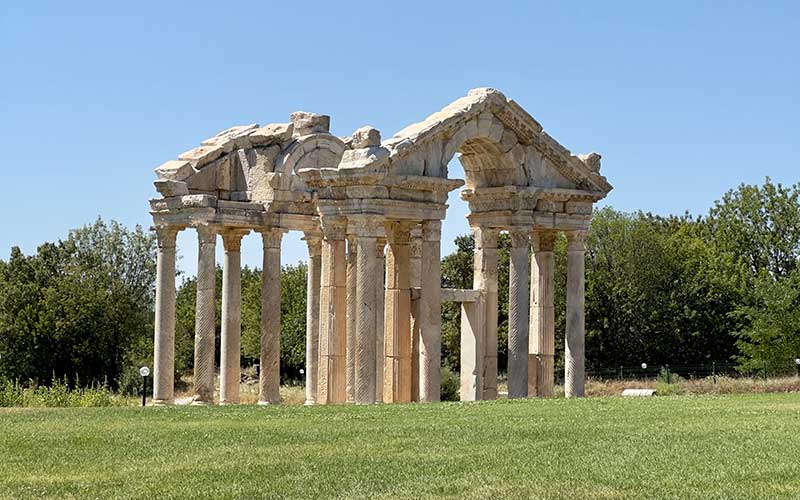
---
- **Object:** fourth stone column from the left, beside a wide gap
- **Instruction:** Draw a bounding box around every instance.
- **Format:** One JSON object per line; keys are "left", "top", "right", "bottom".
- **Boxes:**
{"left": 258, "top": 228, "right": 284, "bottom": 405}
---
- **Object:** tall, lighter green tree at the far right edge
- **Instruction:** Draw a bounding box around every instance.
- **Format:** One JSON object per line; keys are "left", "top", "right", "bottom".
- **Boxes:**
{"left": 707, "top": 178, "right": 800, "bottom": 371}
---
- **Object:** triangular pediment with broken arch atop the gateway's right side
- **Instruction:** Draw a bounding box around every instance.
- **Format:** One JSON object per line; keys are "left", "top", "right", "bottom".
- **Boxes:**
{"left": 382, "top": 88, "right": 612, "bottom": 195}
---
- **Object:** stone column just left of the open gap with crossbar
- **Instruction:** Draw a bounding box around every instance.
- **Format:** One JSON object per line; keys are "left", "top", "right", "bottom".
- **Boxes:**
{"left": 419, "top": 220, "right": 442, "bottom": 401}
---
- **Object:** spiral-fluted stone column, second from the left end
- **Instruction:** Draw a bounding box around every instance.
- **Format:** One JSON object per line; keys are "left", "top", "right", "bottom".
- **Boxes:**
{"left": 192, "top": 225, "right": 217, "bottom": 405}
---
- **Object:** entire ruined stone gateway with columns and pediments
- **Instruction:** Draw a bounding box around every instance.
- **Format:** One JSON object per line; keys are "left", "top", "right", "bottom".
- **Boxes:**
{"left": 150, "top": 88, "right": 612, "bottom": 404}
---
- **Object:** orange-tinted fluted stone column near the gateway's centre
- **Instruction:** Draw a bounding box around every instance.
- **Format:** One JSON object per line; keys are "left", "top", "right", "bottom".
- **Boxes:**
{"left": 383, "top": 222, "right": 411, "bottom": 403}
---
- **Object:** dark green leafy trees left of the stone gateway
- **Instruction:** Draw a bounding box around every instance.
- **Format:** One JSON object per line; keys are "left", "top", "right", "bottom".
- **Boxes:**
{"left": 0, "top": 219, "right": 155, "bottom": 386}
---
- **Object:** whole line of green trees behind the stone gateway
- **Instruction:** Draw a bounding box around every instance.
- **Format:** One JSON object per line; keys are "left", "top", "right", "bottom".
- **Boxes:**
{"left": 0, "top": 179, "right": 800, "bottom": 391}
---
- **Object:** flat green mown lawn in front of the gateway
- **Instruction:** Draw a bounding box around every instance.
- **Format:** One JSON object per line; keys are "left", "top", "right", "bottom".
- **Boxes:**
{"left": 0, "top": 394, "right": 800, "bottom": 500}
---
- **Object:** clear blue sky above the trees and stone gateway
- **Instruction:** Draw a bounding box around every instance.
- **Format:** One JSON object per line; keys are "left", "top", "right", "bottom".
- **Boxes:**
{"left": 0, "top": 0, "right": 800, "bottom": 274}
